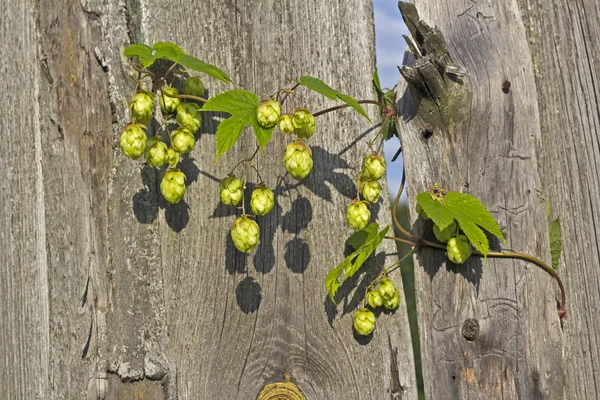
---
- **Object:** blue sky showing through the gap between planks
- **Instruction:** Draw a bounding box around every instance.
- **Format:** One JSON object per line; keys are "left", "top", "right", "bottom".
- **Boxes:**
{"left": 373, "top": 0, "right": 408, "bottom": 196}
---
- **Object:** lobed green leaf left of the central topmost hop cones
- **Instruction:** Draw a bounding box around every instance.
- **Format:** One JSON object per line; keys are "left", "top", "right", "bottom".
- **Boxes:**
{"left": 200, "top": 90, "right": 274, "bottom": 161}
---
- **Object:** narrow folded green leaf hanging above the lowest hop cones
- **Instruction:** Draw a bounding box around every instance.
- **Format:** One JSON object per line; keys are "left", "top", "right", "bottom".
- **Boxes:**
{"left": 325, "top": 222, "right": 390, "bottom": 304}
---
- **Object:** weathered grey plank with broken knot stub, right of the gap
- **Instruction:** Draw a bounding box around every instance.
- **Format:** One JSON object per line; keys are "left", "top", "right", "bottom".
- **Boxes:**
{"left": 399, "top": 0, "right": 565, "bottom": 399}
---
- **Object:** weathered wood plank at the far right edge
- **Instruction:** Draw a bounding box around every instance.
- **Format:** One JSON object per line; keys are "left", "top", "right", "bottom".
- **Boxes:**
{"left": 520, "top": 1, "right": 600, "bottom": 399}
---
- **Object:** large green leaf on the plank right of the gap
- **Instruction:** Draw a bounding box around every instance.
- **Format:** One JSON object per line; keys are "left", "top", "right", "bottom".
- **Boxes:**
{"left": 417, "top": 192, "right": 506, "bottom": 256}
